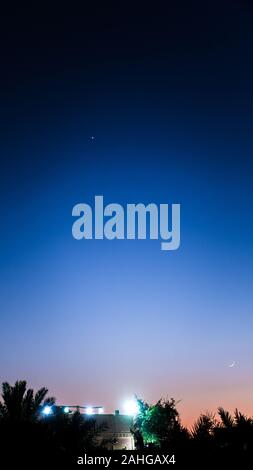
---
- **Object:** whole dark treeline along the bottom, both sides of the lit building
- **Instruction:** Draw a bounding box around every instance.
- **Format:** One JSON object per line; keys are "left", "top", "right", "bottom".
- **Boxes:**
{"left": 0, "top": 381, "right": 253, "bottom": 469}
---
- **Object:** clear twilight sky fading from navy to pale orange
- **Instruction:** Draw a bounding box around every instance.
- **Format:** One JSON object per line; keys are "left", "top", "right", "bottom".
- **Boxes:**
{"left": 0, "top": 0, "right": 253, "bottom": 424}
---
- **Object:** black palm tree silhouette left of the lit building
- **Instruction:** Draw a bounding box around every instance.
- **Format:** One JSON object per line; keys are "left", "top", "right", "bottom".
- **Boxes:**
{"left": 0, "top": 380, "right": 100, "bottom": 468}
